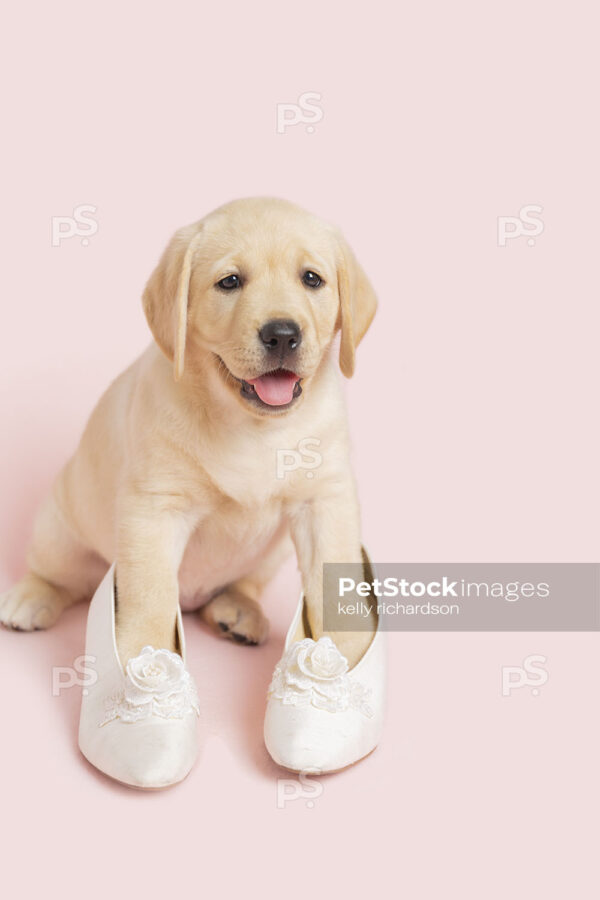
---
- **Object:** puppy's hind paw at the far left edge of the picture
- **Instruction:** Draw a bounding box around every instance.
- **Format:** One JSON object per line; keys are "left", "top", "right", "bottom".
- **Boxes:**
{"left": 0, "top": 573, "right": 65, "bottom": 631}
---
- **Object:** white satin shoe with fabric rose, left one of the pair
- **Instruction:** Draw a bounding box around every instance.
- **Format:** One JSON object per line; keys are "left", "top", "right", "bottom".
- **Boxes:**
{"left": 79, "top": 565, "right": 198, "bottom": 789}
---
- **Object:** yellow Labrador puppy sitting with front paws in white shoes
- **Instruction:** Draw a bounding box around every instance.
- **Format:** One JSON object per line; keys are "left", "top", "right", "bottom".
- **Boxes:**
{"left": 0, "top": 198, "right": 376, "bottom": 665}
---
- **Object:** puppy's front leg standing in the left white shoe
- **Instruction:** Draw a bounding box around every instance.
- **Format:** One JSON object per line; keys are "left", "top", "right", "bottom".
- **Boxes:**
{"left": 116, "top": 492, "right": 198, "bottom": 665}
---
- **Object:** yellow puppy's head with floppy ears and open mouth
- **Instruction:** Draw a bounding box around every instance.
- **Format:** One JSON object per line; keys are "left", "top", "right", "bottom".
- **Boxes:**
{"left": 143, "top": 198, "right": 376, "bottom": 415}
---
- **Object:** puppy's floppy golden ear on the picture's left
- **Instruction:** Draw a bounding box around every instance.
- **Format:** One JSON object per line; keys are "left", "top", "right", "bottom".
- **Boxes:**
{"left": 142, "top": 223, "right": 202, "bottom": 381}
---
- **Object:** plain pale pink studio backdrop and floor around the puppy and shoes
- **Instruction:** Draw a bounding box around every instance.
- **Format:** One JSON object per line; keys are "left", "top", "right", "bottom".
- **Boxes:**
{"left": 0, "top": 0, "right": 600, "bottom": 900}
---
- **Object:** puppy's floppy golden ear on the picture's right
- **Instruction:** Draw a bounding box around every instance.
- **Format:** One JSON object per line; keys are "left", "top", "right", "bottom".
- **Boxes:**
{"left": 337, "top": 235, "right": 377, "bottom": 378}
